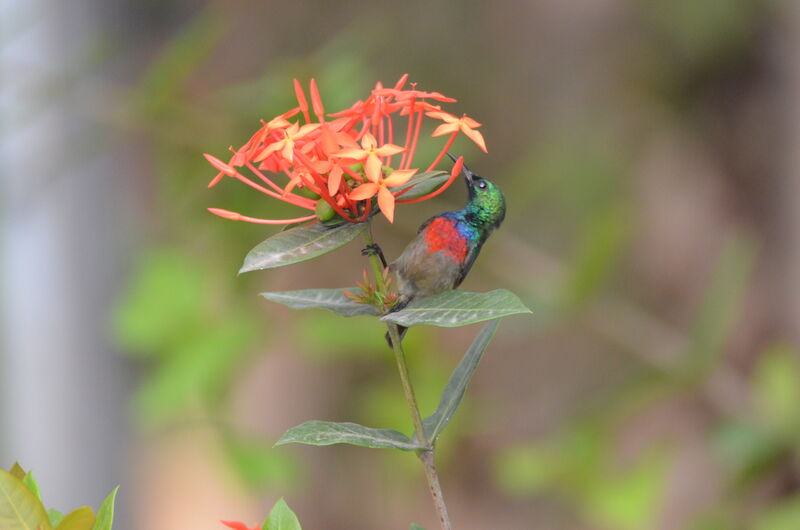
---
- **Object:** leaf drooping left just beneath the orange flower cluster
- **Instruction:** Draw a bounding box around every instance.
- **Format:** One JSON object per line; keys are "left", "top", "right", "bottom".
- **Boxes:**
{"left": 239, "top": 223, "right": 368, "bottom": 274}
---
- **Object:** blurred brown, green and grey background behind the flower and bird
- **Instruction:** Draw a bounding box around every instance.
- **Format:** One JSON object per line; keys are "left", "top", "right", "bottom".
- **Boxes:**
{"left": 0, "top": 0, "right": 800, "bottom": 530}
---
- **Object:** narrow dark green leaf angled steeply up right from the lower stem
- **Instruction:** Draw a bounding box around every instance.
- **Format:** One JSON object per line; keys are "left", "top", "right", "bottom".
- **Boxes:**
{"left": 422, "top": 319, "right": 500, "bottom": 444}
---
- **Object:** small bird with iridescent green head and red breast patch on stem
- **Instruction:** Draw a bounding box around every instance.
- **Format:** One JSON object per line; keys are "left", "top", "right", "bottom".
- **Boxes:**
{"left": 365, "top": 153, "right": 506, "bottom": 346}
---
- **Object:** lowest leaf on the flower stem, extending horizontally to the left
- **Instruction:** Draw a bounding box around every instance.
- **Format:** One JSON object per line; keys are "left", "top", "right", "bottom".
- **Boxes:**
{"left": 275, "top": 420, "right": 424, "bottom": 451}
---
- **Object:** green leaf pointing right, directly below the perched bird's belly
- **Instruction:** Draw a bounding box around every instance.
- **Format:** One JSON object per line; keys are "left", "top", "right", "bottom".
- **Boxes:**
{"left": 381, "top": 289, "right": 531, "bottom": 328}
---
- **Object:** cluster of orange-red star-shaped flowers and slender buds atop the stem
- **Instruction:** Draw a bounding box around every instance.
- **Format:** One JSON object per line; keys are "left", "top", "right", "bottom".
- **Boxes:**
{"left": 205, "top": 74, "right": 486, "bottom": 224}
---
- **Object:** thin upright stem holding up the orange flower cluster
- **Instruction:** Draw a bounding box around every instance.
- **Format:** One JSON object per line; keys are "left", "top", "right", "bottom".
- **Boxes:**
{"left": 364, "top": 226, "right": 452, "bottom": 530}
